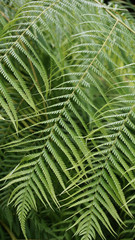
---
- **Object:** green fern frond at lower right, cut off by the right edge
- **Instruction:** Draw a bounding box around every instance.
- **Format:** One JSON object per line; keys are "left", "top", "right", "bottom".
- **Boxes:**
{"left": 67, "top": 80, "right": 135, "bottom": 239}
